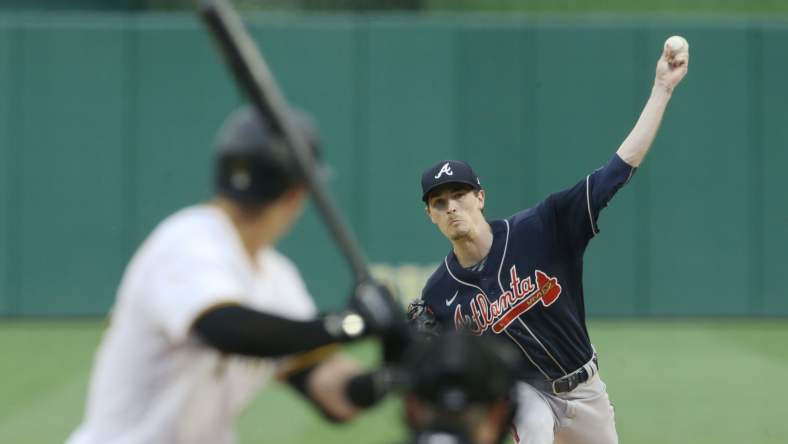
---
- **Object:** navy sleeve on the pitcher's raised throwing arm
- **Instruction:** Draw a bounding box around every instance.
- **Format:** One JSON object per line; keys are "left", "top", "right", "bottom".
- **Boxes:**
{"left": 543, "top": 154, "right": 636, "bottom": 251}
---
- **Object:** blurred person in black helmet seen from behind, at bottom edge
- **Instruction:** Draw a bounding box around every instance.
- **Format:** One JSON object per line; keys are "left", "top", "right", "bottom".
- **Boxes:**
{"left": 405, "top": 333, "right": 519, "bottom": 444}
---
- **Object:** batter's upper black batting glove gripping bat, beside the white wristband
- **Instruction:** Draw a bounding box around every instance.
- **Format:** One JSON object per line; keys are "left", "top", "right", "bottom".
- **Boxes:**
{"left": 348, "top": 281, "right": 411, "bottom": 362}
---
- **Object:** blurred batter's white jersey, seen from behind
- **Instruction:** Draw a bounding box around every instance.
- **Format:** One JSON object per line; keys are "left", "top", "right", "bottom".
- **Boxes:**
{"left": 68, "top": 206, "right": 316, "bottom": 444}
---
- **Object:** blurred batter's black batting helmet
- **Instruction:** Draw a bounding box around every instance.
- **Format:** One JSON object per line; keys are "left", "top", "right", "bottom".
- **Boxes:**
{"left": 215, "top": 106, "right": 318, "bottom": 206}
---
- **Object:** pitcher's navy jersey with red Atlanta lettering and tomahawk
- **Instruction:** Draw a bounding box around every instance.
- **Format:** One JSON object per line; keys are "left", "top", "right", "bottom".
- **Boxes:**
{"left": 421, "top": 155, "right": 635, "bottom": 380}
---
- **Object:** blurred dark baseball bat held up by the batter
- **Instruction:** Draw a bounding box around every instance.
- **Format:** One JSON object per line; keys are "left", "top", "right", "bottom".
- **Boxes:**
{"left": 195, "top": 0, "right": 372, "bottom": 284}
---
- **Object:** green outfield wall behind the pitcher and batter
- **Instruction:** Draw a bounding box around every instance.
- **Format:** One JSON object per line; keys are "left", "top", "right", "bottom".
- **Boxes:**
{"left": 0, "top": 14, "right": 788, "bottom": 316}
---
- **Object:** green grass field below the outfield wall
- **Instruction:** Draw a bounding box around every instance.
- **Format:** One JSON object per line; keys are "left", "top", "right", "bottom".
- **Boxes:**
{"left": 0, "top": 320, "right": 788, "bottom": 444}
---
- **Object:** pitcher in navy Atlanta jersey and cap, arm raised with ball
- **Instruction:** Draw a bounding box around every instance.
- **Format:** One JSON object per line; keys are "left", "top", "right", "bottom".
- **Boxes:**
{"left": 409, "top": 38, "right": 689, "bottom": 444}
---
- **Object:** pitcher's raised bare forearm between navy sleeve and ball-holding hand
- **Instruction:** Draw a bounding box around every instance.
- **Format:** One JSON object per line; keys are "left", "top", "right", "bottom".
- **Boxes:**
{"left": 616, "top": 83, "right": 672, "bottom": 167}
